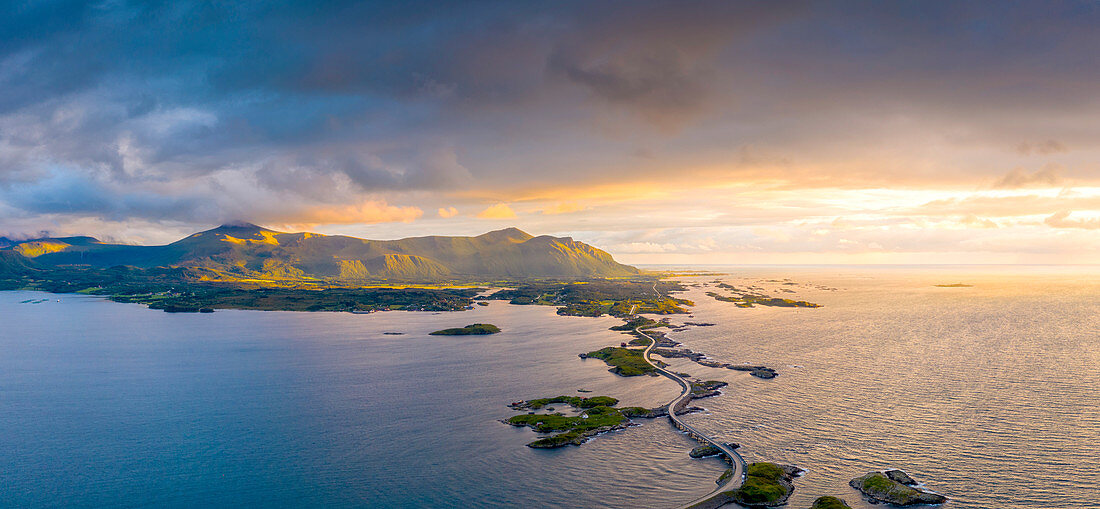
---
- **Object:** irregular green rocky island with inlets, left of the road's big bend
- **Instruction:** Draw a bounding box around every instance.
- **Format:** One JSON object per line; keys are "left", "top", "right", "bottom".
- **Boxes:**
{"left": 502, "top": 396, "right": 668, "bottom": 449}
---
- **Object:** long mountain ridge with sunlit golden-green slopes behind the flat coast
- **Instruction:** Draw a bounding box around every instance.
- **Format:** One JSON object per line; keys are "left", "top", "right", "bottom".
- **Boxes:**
{"left": 3, "top": 224, "right": 638, "bottom": 280}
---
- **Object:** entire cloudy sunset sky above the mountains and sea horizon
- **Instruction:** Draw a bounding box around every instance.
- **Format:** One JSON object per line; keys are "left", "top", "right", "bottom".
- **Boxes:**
{"left": 0, "top": 0, "right": 1100, "bottom": 264}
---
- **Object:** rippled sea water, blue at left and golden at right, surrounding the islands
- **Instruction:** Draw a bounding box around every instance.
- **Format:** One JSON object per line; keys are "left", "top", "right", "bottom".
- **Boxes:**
{"left": 0, "top": 267, "right": 1100, "bottom": 508}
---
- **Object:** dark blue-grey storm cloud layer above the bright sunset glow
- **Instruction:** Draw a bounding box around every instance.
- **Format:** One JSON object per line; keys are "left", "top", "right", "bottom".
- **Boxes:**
{"left": 0, "top": 1, "right": 1100, "bottom": 227}
